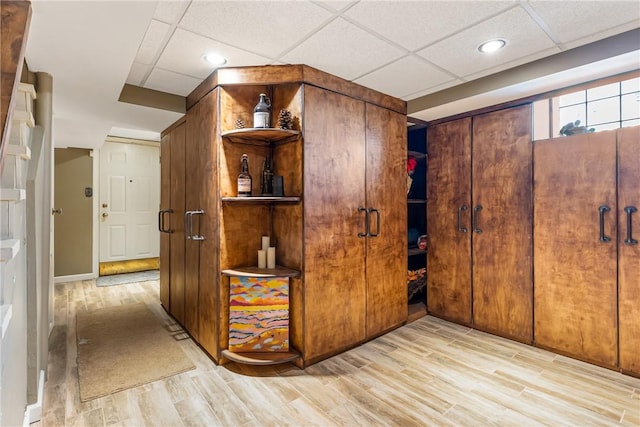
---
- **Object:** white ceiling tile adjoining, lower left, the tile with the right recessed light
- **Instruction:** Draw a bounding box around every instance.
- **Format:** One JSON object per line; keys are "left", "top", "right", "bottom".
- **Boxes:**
{"left": 355, "top": 55, "right": 454, "bottom": 98}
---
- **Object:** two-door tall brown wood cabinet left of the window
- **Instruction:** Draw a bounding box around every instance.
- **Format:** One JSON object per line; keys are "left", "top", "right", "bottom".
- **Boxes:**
{"left": 427, "top": 105, "right": 533, "bottom": 342}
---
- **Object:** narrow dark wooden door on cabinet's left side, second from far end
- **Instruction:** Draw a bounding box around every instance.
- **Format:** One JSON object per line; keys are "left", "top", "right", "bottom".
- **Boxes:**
{"left": 169, "top": 124, "right": 185, "bottom": 325}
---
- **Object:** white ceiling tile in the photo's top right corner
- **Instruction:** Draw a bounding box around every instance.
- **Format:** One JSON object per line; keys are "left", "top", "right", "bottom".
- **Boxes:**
{"left": 530, "top": 0, "right": 640, "bottom": 43}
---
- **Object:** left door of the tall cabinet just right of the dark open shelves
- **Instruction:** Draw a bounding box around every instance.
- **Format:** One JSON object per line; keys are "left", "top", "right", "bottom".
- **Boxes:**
{"left": 427, "top": 118, "right": 471, "bottom": 324}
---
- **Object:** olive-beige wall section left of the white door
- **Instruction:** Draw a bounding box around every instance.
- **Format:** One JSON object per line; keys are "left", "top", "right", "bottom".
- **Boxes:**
{"left": 54, "top": 148, "right": 95, "bottom": 277}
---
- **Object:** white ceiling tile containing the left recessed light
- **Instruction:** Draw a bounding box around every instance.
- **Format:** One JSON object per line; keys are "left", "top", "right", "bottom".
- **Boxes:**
{"left": 157, "top": 28, "right": 269, "bottom": 79}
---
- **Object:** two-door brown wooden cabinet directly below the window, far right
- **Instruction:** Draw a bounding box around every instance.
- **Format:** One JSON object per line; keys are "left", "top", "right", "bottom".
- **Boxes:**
{"left": 534, "top": 128, "right": 640, "bottom": 373}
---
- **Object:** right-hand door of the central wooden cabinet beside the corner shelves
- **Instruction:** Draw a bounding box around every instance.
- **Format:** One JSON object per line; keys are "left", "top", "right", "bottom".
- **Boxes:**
{"left": 366, "top": 104, "right": 407, "bottom": 338}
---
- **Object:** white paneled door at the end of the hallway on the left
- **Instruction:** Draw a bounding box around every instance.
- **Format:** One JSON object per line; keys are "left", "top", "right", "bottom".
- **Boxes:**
{"left": 99, "top": 142, "right": 160, "bottom": 262}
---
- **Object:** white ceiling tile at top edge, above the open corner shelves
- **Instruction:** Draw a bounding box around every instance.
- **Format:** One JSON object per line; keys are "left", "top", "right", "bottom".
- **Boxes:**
{"left": 180, "top": 1, "right": 331, "bottom": 58}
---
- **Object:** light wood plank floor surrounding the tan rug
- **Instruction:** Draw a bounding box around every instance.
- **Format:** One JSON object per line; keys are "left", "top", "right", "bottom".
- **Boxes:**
{"left": 38, "top": 281, "right": 640, "bottom": 426}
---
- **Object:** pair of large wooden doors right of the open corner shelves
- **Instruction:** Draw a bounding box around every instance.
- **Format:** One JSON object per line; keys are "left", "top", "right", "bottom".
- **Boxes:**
{"left": 304, "top": 86, "right": 407, "bottom": 360}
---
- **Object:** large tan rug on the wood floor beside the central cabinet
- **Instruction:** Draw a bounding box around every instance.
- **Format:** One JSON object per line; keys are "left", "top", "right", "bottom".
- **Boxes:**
{"left": 76, "top": 303, "right": 195, "bottom": 402}
